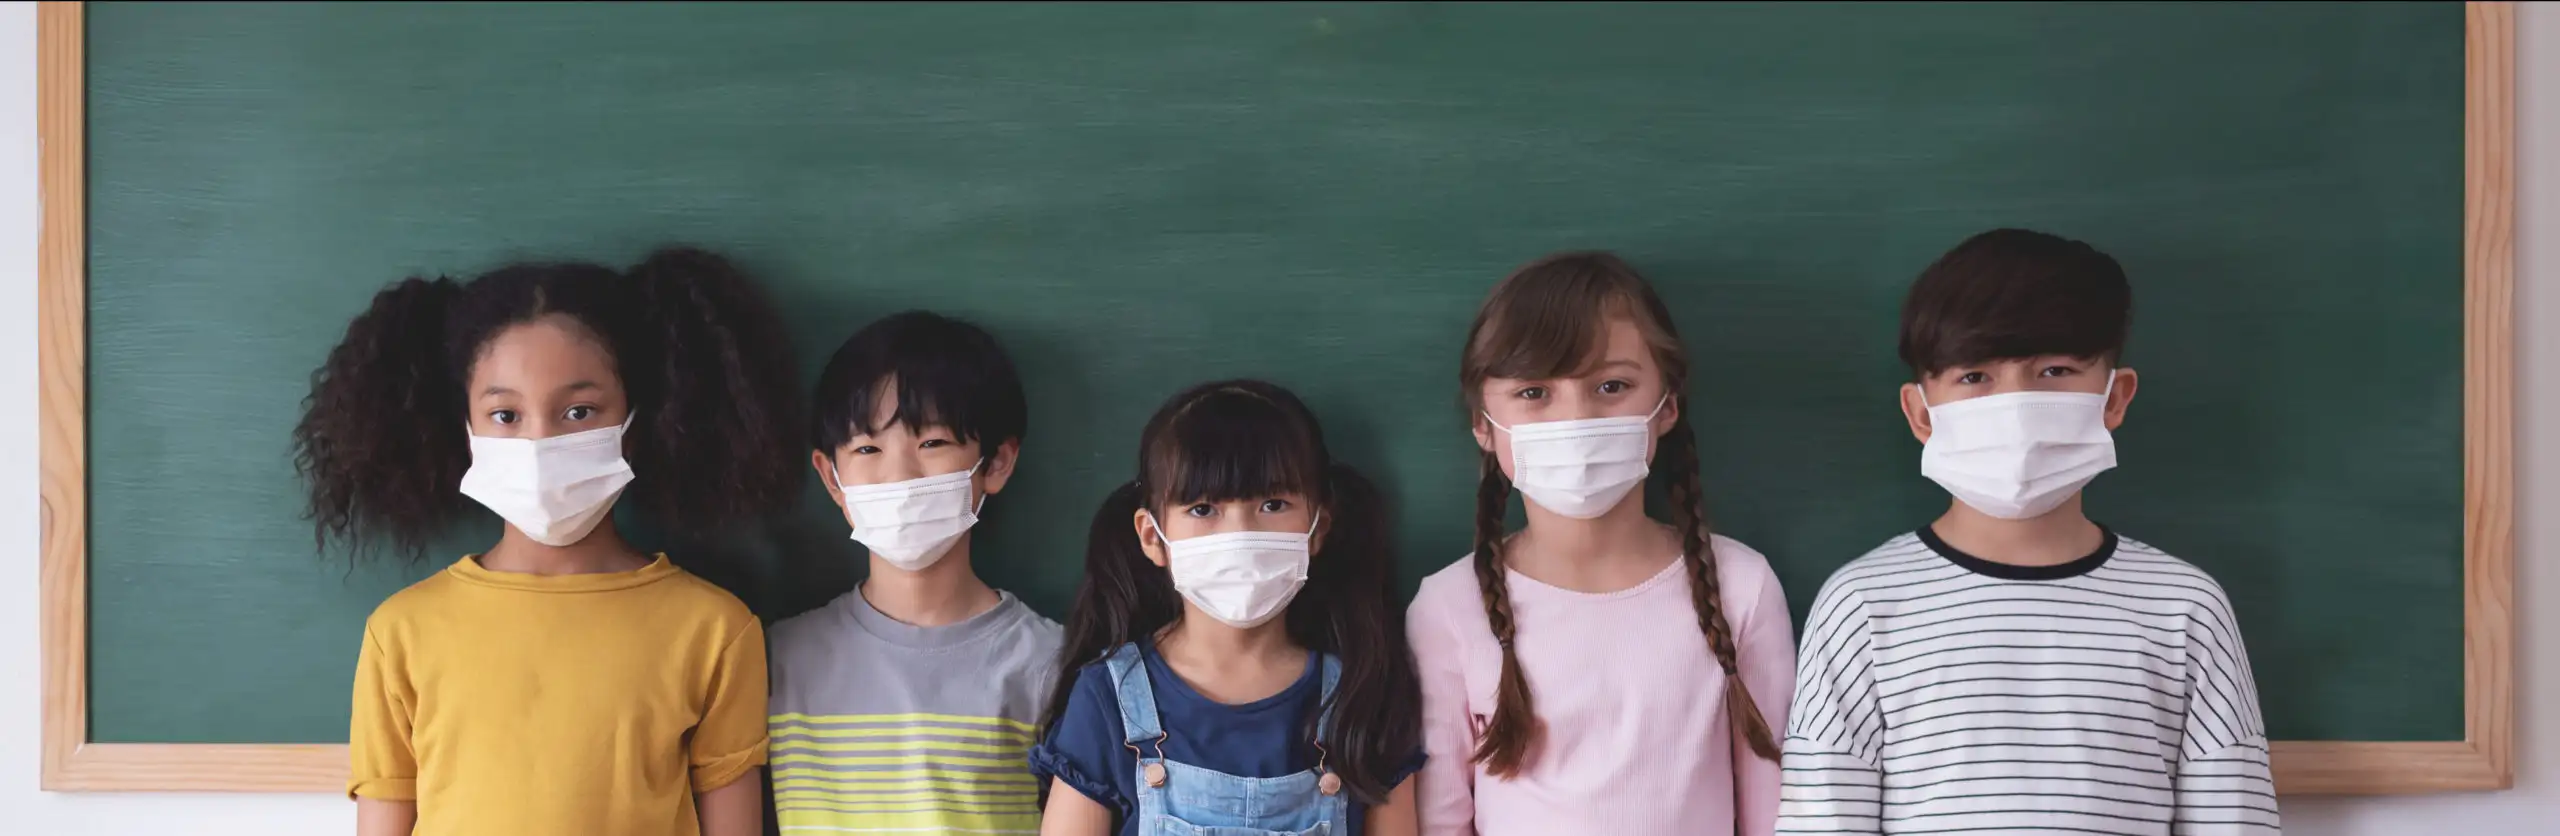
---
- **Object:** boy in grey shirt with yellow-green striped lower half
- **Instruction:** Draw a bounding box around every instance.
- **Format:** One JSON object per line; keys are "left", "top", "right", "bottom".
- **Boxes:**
{"left": 771, "top": 312, "right": 1060, "bottom": 833}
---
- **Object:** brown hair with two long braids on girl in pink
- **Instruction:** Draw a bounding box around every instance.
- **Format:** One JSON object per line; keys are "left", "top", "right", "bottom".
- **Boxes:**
{"left": 1459, "top": 253, "right": 1779, "bottom": 777}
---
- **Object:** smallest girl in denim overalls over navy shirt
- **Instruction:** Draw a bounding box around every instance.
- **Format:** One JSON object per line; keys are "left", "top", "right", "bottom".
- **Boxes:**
{"left": 1032, "top": 381, "right": 1421, "bottom": 836}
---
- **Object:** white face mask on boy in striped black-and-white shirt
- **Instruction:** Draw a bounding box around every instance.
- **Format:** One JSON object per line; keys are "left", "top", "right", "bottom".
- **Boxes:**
{"left": 1920, "top": 371, "right": 2115, "bottom": 519}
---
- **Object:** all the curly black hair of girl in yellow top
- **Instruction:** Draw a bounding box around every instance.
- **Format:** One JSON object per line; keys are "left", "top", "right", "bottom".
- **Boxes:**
{"left": 294, "top": 248, "right": 801, "bottom": 560}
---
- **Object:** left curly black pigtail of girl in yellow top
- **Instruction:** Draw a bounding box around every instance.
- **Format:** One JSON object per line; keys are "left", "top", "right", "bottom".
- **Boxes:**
{"left": 294, "top": 279, "right": 471, "bottom": 562}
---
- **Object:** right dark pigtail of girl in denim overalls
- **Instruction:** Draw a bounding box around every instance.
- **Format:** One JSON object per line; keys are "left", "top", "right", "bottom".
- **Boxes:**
{"left": 1288, "top": 463, "right": 1423, "bottom": 805}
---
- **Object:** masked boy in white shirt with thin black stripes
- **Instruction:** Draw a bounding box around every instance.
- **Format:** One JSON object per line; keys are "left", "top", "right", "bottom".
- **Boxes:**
{"left": 1779, "top": 230, "right": 2278, "bottom": 836}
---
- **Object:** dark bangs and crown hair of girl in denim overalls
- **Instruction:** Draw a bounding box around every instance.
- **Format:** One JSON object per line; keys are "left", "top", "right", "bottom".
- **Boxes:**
{"left": 1144, "top": 389, "right": 1326, "bottom": 506}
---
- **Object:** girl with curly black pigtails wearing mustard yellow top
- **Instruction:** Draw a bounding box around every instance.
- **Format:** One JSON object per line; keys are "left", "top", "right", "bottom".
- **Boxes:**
{"left": 294, "top": 248, "right": 799, "bottom": 836}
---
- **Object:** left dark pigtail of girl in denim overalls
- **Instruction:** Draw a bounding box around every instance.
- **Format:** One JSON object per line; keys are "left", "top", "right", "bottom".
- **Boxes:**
{"left": 1042, "top": 481, "right": 1183, "bottom": 726}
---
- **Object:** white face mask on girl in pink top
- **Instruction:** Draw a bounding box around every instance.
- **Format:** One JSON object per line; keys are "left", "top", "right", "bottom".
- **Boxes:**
{"left": 1485, "top": 396, "right": 1672, "bottom": 519}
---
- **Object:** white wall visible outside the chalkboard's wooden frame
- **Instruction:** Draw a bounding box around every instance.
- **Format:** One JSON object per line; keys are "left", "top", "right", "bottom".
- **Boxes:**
{"left": 0, "top": 3, "right": 2560, "bottom": 836}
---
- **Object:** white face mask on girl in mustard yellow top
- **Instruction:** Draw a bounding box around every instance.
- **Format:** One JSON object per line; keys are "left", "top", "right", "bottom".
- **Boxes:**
{"left": 463, "top": 417, "right": 632, "bottom": 547}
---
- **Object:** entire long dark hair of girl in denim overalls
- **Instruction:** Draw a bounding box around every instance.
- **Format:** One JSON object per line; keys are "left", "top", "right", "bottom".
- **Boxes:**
{"left": 1044, "top": 381, "right": 1421, "bottom": 805}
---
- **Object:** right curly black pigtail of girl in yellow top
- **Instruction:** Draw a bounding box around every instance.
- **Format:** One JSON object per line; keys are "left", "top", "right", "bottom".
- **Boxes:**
{"left": 617, "top": 248, "right": 804, "bottom": 532}
